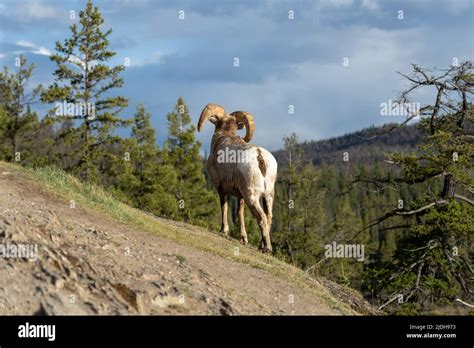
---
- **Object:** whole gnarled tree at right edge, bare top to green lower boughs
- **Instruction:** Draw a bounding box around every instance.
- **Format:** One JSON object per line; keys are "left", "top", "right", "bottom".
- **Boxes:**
{"left": 341, "top": 62, "right": 474, "bottom": 307}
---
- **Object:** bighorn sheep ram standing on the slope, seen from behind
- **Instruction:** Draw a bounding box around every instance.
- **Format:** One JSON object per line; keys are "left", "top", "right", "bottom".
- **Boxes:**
{"left": 197, "top": 104, "right": 277, "bottom": 252}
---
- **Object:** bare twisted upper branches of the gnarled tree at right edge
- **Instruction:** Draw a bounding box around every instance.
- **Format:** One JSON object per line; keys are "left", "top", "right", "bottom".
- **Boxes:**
{"left": 350, "top": 62, "right": 474, "bottom": 223}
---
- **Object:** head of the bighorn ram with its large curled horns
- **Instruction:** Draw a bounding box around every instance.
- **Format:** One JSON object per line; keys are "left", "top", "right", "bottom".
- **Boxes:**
{"left": 198, "top": 104, "right": 255, "bottom": 143}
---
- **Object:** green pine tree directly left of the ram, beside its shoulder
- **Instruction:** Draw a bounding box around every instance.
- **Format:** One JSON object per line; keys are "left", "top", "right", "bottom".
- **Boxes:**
{"left": 164, "top": 97, "right": 219, "bottom": 226}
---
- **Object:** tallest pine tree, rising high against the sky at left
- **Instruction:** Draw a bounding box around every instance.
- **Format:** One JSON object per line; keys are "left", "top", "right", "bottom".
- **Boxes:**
{"left": 42, "top": 0, "right": 128, "bottom": 179}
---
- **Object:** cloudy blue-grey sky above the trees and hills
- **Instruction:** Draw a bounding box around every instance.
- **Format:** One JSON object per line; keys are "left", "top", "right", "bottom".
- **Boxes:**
{"left": 0, "top": 0, "right": 474, "bottom": 150}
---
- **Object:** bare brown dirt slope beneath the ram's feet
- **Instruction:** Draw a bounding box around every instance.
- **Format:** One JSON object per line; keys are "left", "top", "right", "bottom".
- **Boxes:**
{"left": 0, "top": 162, "right": 378, "bottom": 315}
